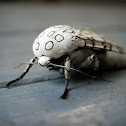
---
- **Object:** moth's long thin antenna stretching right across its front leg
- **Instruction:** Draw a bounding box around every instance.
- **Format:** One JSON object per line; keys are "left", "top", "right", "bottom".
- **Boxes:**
{"left": 48, "top": 62, "right": 112, "bottom": 82}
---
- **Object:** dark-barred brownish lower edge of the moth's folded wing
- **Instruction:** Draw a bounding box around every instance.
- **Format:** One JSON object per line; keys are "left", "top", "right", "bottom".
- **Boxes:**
{"left": 73, "top": 35, "right": 126, "bottom": 54}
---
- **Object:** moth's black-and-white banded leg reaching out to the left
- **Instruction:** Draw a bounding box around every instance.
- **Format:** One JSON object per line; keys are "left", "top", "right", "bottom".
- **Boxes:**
{"left": 6, "top": 57, "right": 37, "bottom": 88}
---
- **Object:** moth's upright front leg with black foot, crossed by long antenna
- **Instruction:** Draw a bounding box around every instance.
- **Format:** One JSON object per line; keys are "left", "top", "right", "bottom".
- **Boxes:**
{"left": 61, "top": 56, "right": 70, "bottom": 99}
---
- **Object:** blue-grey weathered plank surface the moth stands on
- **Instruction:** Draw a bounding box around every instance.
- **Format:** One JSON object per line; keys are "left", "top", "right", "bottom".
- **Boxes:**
{"left": 0, "top": 3, "right": 126, "bottom": 126}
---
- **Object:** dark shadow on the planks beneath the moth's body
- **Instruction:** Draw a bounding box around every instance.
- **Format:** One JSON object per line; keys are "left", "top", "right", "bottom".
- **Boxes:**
{"left": 70, "top": 68, "right": 126, "bottom": 90}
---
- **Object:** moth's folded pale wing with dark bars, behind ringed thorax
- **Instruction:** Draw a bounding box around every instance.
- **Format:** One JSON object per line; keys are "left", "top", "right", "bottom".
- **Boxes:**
{"left": 74, "top": 29, "right": 126, "bottom": 53}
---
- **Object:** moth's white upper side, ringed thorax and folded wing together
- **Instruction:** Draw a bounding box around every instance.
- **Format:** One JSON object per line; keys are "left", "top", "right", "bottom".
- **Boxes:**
{"left": 33, "top": 25, "right": 126, "bottom": 58}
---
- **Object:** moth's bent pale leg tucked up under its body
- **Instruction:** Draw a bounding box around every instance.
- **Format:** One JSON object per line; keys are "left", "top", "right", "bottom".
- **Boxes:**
{"left": 81, "top": 54, "right": 99, "bottom": 70}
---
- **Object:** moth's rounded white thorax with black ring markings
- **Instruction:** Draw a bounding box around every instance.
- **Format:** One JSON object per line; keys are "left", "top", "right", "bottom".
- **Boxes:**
{"left": 33, "top": 25, "right": 77, "bottom": 58}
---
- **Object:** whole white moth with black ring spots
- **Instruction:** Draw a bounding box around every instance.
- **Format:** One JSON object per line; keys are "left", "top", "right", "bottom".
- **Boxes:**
{"left": 6, "top": 25, "right": 126, "bottom": 99}
